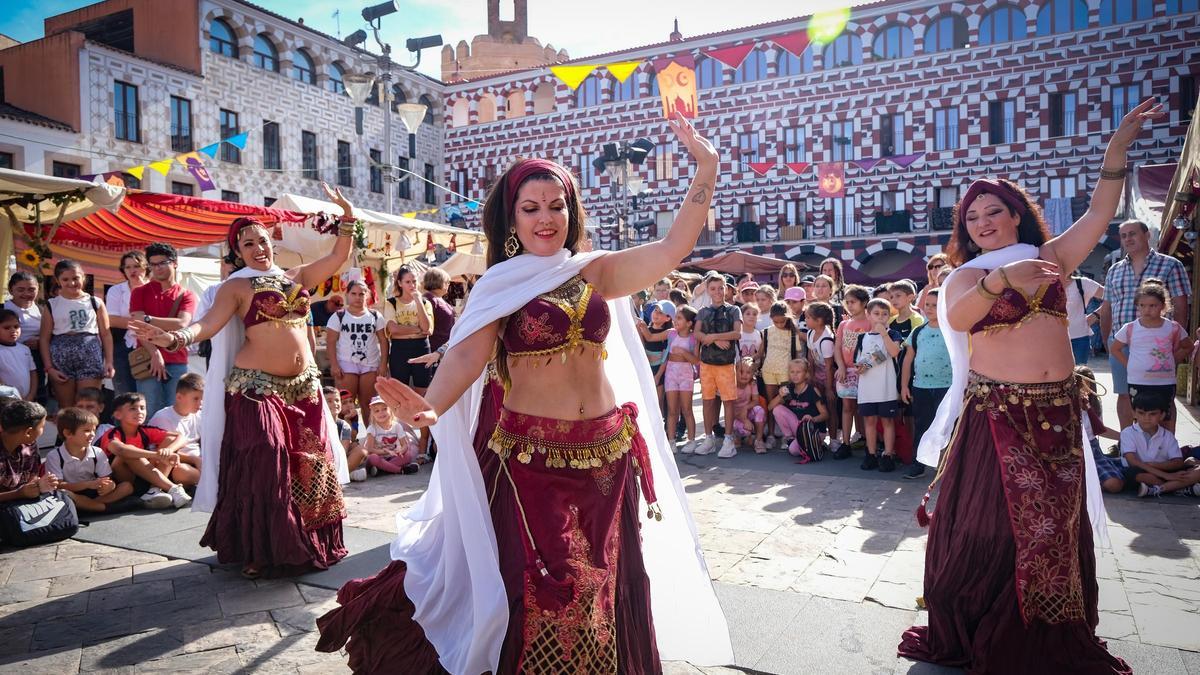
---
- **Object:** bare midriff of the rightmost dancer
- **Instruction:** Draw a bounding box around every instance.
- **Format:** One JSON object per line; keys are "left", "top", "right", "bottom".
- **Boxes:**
{"left": 971, "top": 313, "right": 1075, "bottom": 383}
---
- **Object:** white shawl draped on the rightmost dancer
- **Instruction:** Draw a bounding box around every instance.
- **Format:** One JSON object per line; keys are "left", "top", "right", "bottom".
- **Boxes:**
{"left": 917, "top": 244, "right": 1109, "bottom": 546}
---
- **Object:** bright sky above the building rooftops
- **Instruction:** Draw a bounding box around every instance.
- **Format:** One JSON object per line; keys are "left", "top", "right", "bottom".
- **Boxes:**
{"left": 0, "top": 0, "right": 866, "bottom": 77}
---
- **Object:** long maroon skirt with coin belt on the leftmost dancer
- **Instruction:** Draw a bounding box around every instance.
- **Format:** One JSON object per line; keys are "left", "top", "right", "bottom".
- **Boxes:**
{"left": 200, "top": 366, "right": 346, "bottom": 577}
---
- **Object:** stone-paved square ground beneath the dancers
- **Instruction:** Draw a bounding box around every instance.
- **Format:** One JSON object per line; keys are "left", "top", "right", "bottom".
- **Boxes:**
{"left": 0, "top": 365, "right": 1200, "bottom": 675}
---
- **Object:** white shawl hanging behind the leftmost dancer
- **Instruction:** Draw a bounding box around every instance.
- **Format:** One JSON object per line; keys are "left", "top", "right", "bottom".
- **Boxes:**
{"left": 192, "top": 265, "right": 350, "bottom": 513}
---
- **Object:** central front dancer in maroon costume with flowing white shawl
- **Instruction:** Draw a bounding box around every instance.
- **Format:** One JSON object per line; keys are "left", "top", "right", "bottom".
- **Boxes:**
{"left": 317, "top": 112, "right": 733, "bottom": 675}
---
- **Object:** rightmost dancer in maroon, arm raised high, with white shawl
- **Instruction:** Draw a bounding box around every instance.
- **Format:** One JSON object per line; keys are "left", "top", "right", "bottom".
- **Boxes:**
{"left": 899, "top": 98, "right": 1164, "bottom": 674}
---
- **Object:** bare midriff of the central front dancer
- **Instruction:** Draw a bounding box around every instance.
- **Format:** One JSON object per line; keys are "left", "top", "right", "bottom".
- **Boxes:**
{"left": 504, "top": 355, "right": 617, "bottom": 419}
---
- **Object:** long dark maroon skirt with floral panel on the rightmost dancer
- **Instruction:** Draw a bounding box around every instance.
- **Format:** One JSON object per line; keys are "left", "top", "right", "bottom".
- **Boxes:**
{"left": 899, "top": 372, "right": 1132, "bottom": 674}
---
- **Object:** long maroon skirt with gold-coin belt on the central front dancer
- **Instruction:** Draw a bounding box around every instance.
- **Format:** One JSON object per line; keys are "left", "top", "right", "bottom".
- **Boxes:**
{"left": 317, "top": 374, "right": 661, "bottom": 674}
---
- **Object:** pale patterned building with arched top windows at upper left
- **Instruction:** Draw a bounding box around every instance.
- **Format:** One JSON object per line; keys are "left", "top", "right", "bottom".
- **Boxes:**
{"left": 0, "top": 0, "right": 445, "bottom": 213}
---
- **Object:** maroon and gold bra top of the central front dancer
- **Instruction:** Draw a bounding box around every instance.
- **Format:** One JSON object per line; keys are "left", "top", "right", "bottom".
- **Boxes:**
{"left": 500, "top": 275, "right": 611, "bottom": 365}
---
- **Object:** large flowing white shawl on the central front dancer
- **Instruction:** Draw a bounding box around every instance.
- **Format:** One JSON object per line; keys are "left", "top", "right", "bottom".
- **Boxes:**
{"left": 391, "top": 250, "right": 733, "bottom": 675}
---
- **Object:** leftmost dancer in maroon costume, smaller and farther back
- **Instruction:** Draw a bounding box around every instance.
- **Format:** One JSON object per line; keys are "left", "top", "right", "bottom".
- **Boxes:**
{"left": 130, "top": 184, "right": 354, "bottom": 578}
